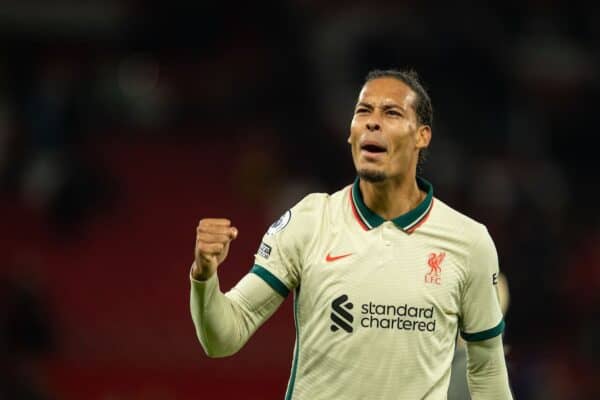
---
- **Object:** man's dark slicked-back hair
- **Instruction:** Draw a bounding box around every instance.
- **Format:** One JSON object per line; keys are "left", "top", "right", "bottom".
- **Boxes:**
{"left": 365, "top": 69, "right": 433, "bottom": 168}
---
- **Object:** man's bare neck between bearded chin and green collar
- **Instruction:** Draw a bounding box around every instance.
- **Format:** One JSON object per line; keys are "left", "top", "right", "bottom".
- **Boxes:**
{"left": 359, "top": 176, "right": 426, "bottom": 220}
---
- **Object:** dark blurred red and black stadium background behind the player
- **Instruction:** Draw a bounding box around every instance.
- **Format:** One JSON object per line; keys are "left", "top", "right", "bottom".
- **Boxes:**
{"left": 0, "top": 0, "right": 600, "bottom": 400}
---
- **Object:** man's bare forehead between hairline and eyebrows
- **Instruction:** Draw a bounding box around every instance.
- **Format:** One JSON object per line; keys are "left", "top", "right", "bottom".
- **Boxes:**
{"left": 358, "top": 77, "right": 416, "bottom": 107}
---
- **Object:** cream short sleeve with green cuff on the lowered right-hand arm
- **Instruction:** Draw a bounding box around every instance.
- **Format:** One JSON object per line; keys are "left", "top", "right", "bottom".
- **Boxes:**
{"left": 460, "top": 227, "right": 504, "bottom": 341}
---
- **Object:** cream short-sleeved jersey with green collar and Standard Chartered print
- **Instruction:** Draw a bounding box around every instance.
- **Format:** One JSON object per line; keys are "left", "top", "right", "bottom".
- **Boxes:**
{"left": 251, "top": 178, "right": 504, "bottom": 400}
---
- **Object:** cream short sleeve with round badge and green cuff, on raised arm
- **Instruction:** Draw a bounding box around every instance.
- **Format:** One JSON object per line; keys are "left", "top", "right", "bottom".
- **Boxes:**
{"left": 251, "top": 194, "right": 321, "bottom": 297}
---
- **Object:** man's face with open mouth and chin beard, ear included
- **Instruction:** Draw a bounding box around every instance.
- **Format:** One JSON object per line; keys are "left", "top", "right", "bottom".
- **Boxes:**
{"left": 348, "top": 77, "right": 431, "bottom": 182}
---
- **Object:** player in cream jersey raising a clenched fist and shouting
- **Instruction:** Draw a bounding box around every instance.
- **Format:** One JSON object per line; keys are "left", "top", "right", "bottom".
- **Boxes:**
{"left": 190, "top": 70, "right": 512, "bottom": 400}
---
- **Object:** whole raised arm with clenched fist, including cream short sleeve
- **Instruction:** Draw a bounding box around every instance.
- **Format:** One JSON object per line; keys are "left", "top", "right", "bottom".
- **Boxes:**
{"left": 190, "top": 195, "right": 316, "bottom": 357}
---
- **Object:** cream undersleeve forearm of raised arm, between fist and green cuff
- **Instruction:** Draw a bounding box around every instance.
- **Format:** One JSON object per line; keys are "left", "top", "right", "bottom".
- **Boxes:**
{"left": 190, "top": 262, "right": 284, "bottom": 357}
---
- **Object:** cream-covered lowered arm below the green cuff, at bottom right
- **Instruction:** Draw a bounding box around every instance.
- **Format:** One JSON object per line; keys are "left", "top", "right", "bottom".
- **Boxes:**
{"left": 467, "top": 335, "right": 513, "bottom": 400}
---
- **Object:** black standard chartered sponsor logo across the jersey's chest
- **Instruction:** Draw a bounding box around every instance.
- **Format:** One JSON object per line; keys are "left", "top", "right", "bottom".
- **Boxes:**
{"left": 331, "top": 294, "right": 436, "bottom": 333}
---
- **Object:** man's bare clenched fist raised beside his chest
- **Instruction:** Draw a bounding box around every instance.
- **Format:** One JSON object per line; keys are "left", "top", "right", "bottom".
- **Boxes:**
{"left": 192, "top": 218, "right": 238, "bottom": 281}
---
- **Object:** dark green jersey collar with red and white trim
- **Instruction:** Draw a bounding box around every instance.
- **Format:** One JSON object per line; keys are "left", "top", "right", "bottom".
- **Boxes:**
{"left": 350, "top": 177, "right": 433, "bottom": 233}
